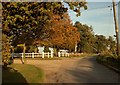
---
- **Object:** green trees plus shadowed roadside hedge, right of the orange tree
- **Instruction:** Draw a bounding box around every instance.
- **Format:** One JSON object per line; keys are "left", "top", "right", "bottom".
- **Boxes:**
{"left": 74, "top": 22, "right": 120, "bottom": 70}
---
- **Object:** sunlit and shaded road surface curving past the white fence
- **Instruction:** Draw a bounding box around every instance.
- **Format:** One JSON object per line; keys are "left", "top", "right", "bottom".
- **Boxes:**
{"left": 15, "top": 57, "right": 120, "bottom": 83}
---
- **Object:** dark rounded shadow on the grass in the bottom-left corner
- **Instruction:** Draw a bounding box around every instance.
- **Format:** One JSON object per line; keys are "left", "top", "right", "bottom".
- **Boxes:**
{"left": 2, "top": 67, "right": 28, "bottom": 85}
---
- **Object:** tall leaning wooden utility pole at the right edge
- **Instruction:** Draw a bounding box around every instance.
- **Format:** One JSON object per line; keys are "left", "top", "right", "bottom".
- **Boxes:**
{"left": 113, "top": 0, "right": 120, "bottom": 56}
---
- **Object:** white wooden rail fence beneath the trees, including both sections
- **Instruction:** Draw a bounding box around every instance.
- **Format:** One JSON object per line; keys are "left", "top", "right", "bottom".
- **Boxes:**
{"left": 12, "top": 52, "right": 69, "bottom": 58}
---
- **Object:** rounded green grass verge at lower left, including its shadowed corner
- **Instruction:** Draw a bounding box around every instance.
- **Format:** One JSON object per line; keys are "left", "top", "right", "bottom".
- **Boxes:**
{"left": 2, "top": 64, "right": 44, "bottom": 83}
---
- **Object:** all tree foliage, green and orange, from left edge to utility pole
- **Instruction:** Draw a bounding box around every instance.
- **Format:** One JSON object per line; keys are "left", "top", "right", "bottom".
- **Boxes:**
{"left": 2, "top": 0, "right": 116, "bottom": 69}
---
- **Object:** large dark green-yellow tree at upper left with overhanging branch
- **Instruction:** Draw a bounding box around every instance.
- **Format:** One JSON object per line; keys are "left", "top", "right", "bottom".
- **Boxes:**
{"left": 2, "top": 2, "right": 86, "bottom": 45}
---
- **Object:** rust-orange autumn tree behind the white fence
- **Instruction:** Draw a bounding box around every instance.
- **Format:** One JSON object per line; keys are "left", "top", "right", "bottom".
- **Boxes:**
{"left": 49, "top": 13, "right": 79, "bottom": 53}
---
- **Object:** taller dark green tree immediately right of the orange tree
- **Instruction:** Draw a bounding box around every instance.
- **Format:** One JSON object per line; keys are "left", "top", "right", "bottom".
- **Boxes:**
{"left": 74, "top": 22, "right": 95, "bottom": 53}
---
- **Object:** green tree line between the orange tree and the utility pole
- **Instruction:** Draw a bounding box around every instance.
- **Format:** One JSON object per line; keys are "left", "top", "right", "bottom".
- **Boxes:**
{"left": 74, "top": 21, "right": 116, "bottom": 54}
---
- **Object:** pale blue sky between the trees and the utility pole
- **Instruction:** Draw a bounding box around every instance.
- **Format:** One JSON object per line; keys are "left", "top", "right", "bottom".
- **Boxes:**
{"left": 64, "top": 2, "right": 118, "bottom": 37}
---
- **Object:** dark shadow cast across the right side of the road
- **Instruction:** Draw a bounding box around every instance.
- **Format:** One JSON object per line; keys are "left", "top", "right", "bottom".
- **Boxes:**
{"left": 66, "top": 57, "right": 120, "bottom": 85}
